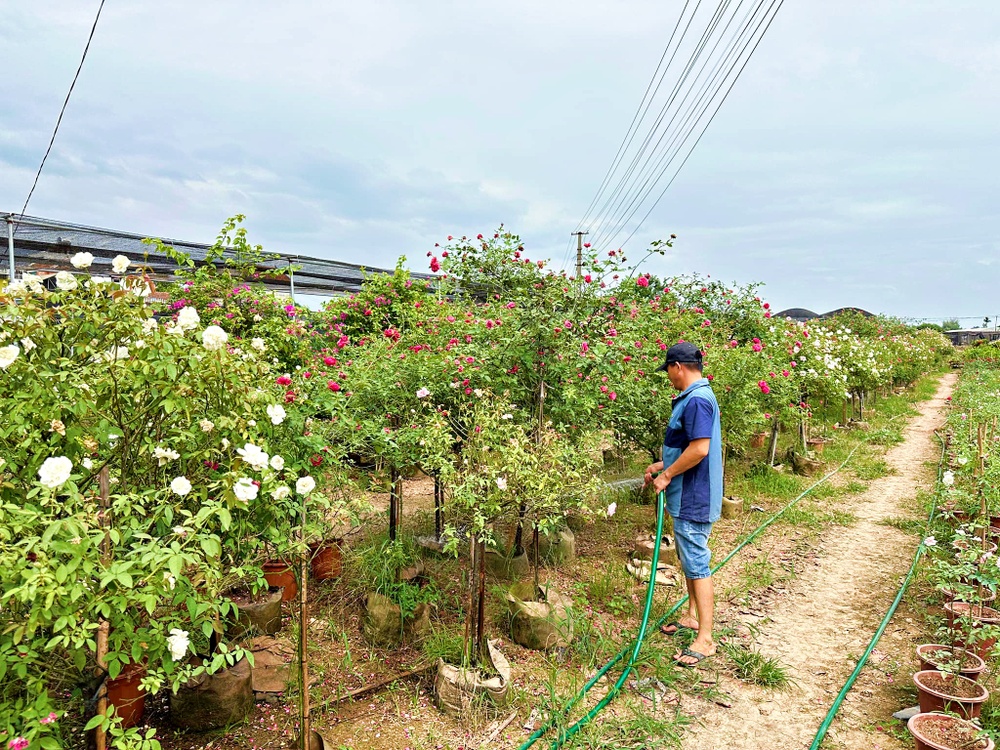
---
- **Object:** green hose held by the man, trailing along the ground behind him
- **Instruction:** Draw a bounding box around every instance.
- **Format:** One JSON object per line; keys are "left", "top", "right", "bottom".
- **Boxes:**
{"left": 518, "top": 441, "right": 865, "bottom": 750}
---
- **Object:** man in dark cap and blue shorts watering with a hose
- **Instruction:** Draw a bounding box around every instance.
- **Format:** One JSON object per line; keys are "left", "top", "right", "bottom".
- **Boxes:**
{"left": 645, "top": 342, "right": 722, "bottom": 667}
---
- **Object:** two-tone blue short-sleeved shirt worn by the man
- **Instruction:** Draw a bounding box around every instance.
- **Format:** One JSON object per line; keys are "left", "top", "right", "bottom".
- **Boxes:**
{"left": 662, "top": 378, "right": 722, "bottom": 523}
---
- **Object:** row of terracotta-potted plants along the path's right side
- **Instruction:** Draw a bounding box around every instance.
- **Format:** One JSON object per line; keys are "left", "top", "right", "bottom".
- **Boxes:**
{"left": 909, "top": 356, "right": 1000, "bottom": 750}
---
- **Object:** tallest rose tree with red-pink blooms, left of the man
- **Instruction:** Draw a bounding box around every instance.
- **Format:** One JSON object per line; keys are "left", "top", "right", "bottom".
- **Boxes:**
{"left": 431, "top": 227, "right": 619, "bottom": 554}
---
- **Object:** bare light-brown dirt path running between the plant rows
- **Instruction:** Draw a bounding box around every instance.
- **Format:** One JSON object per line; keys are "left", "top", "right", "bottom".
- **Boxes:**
{"left": 683, "top": 375, "right": 956, "bottom": 750}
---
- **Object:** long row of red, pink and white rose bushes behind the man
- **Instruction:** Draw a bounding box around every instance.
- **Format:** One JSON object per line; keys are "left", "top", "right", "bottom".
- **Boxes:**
{"left": 0, "top": 217, "right": 952, "bottom": 750}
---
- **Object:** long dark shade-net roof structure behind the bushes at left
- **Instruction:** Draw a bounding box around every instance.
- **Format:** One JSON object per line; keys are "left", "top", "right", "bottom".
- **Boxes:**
{"left": 0, "top": 213, "right": 433, "bottom": 295}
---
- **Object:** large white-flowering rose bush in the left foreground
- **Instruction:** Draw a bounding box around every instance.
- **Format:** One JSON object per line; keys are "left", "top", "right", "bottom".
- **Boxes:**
{"left": 0, "top": 277, "right": 276, "bottom": 747}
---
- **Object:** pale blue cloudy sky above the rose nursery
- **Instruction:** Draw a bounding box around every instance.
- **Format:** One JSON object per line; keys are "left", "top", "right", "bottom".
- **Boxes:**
{"left": 0, "top": 0, "right": 1000, "bottom": 325}
